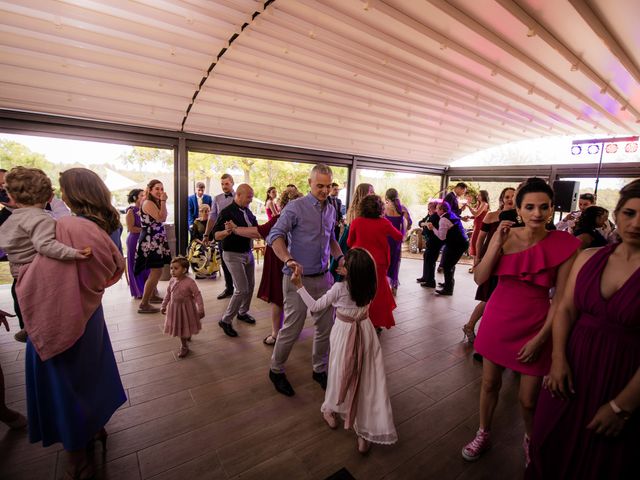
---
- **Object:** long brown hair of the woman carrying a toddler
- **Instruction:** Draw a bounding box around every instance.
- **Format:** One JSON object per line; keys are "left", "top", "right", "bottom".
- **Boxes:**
{"left": 60, "top": 168, "right": 122, "bottom": 234}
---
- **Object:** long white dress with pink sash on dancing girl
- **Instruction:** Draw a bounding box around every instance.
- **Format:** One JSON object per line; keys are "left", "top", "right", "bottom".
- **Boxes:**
{"left": 298, "top": 282, "right": 398, "bottom": 444}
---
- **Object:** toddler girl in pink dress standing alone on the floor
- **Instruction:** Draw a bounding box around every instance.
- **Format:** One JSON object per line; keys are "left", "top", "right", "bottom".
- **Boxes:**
{"left": 161, "top": 257, "right": 204, "bottom": 358}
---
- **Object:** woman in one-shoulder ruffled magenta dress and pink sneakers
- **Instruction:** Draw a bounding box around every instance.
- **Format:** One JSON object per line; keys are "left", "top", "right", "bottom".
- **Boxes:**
{"left": 462, "top": 178, "right": 580, "bottom": 463}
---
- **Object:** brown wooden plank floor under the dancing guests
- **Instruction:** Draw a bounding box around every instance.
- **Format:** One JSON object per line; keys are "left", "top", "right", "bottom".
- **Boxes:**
{"left": 0, "top": 259, "right": 524, "bottom": 480}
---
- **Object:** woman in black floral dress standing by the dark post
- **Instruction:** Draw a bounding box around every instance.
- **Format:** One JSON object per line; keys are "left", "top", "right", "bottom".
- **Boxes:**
{"left": 134, "top": 180, "right": 171, "bottom": 313}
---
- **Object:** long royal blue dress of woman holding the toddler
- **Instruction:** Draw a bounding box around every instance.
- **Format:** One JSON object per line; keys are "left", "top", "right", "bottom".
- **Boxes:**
{"left": 25, "top": 219, "right": 127, "bottom": 451}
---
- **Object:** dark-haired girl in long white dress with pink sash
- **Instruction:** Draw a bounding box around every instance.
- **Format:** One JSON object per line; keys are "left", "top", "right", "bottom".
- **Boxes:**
{"left": 291, "top": 248, "right": 398, "bottom": 453}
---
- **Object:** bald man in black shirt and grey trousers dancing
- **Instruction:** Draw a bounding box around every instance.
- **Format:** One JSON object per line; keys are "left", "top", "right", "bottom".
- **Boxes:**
{"left": 213, "top": 183, "right": 258, "bottom": 337}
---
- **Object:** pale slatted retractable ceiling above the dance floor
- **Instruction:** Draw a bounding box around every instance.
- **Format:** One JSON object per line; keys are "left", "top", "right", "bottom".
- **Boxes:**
{"left": 0, "top": 0, "right": 640, "bottom": 165}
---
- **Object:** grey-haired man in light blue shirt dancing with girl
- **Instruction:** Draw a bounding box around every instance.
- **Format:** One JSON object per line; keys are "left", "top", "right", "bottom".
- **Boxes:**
{"left": 267, "top": 164, "right": 344, "bottom": 396}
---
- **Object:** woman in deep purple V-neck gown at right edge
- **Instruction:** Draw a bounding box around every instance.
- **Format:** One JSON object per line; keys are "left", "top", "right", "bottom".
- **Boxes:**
{"left": 526, "top": 180, "right": 640, "bottom": 480}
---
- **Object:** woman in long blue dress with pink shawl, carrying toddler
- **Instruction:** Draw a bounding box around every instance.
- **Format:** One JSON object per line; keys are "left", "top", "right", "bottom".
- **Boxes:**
{"left": 18, "top": 168, "right": 126, "bottom": 479}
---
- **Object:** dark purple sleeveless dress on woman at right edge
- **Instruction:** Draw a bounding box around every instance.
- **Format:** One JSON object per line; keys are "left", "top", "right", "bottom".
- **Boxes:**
{"left": 525, "top": 245, "right": 640, "bottom": 480}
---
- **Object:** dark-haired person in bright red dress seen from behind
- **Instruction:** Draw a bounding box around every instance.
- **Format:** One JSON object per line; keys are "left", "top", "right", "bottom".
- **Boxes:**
{"left": 347, "top": 195, "right": 402, "bottom": 328}
